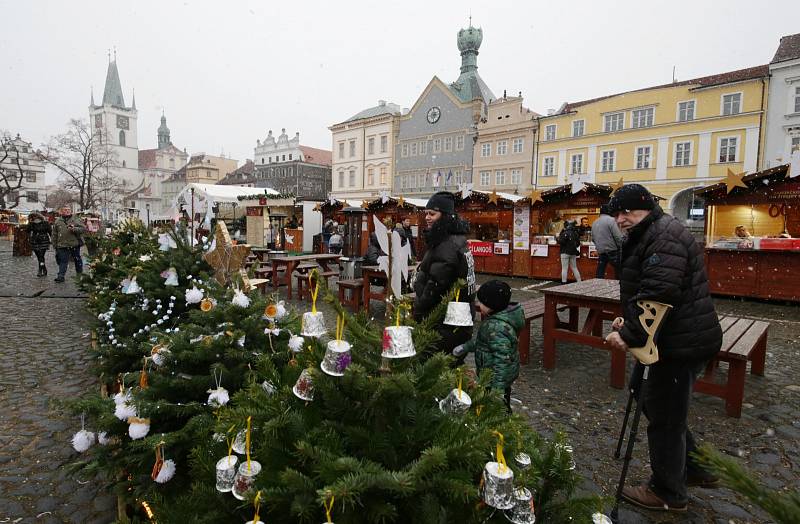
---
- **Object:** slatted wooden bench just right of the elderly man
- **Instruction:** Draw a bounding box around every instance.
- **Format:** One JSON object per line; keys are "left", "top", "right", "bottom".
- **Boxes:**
{"left": 694, "top": 316, "right": 769, "bottom": 418}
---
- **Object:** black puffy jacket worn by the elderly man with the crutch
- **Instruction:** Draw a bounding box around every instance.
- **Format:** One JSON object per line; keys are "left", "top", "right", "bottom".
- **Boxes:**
{"left": 619, "top": 206, "right": 722, "bottom": 361}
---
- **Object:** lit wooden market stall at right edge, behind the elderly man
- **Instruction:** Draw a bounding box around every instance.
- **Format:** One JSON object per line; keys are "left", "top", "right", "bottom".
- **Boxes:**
{"left": 696, "top": 165, "right": 800, "bottom": 302}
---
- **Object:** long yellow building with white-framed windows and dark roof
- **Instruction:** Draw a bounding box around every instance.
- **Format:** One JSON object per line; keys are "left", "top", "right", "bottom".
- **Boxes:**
{"left": 535, "top": 65, "right": 769, "bottom": 219}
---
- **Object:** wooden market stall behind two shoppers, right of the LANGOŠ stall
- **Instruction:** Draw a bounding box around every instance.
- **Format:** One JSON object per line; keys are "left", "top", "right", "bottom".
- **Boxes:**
{"left": 515, "top": 184, "right": 615, "bottom": 280}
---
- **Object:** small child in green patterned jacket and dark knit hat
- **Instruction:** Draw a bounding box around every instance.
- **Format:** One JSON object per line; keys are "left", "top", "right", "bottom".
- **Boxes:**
{"left": 453, "top": 280, "right": 525, "bottom": 413}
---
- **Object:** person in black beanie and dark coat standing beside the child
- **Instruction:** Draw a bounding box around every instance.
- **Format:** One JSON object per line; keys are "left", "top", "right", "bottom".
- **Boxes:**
{"left": 414, "top": 191, "right": 475, "bottom": 353}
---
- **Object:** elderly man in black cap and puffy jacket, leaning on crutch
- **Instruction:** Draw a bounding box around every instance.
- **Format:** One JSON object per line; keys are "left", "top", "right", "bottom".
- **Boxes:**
{"left": 606, "top": 184, "right": 722, "bottom": 511}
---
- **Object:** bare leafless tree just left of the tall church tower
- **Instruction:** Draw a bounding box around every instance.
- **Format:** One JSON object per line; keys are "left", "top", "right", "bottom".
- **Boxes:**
{"left": 42, "top": 118, "right": 123, "bottom": 210}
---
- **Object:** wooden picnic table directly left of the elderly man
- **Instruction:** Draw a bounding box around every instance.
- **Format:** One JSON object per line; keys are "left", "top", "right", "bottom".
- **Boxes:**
{"left": 542, "top": 278, "right": 626, "bottom": 388}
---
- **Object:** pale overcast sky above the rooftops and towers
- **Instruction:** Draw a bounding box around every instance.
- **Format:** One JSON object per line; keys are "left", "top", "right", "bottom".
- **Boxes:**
{"left": 0, "top": 0, "right": 800, "bottom": 166}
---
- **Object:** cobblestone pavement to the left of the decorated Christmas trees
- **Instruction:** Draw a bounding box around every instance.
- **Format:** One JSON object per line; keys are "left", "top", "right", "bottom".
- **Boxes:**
{"left": 0, "top": 246, "right": 116, "bottom": 524}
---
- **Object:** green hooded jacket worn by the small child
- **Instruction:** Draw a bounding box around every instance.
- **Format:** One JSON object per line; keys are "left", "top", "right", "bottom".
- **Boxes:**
{"left": 464, "top": 304, "right": 525, "bottom": 390}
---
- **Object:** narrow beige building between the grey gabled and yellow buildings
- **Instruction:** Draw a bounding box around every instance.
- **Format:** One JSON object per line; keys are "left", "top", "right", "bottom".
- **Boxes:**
{"left": 472, "top": 96, "right": 540, "bottom": 195}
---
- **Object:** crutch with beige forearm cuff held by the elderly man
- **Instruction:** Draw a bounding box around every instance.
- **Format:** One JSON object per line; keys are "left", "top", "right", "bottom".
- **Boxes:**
{"left": 611, "top": 300, "right": 672, "bottom": 522}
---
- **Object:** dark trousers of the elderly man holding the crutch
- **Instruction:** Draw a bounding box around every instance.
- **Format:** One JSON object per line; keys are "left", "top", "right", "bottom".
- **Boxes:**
{"left": 631, "top": 360, "right": 703, "bottom": 506}
